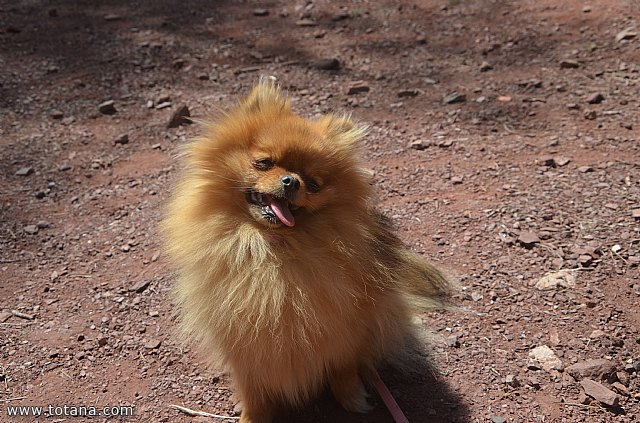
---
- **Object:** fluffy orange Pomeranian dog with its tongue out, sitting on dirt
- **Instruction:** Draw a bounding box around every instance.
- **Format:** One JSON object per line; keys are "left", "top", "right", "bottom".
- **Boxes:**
{"left": 163, "top": 78, "right": 451, "bottom": 423}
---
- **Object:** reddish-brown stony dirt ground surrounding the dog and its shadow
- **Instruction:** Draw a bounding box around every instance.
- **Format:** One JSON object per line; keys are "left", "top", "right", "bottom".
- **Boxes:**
{"left": 0, "top": 0, "right": 640, "bottom": 423}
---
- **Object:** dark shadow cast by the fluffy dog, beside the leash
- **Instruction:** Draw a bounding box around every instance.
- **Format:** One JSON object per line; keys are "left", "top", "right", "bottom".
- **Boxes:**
{"left": 274, "top": 348, "right": 470, "bottom": 423}
